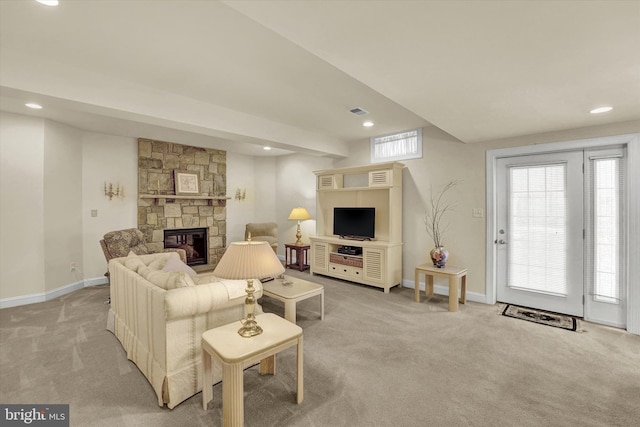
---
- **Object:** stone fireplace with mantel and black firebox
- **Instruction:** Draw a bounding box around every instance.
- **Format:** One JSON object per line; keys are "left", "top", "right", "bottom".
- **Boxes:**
{"left": 138, "top": 138, "right": 227, "bottom": 267}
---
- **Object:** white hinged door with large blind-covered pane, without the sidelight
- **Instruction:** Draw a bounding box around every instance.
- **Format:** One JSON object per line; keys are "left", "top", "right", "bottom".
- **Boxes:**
{"left": 495, "top": 151, "right": 584, "bottom": 317}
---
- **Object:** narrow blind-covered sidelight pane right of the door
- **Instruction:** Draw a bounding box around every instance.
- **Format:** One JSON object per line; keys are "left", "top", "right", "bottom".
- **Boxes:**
{"left": 589, "top": 157, "right": 624, "bottom": 304}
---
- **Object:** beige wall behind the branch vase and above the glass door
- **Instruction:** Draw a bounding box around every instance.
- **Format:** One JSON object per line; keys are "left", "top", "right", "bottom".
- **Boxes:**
{"left": 335, "top": 121, "right": 640, "bottom": 301}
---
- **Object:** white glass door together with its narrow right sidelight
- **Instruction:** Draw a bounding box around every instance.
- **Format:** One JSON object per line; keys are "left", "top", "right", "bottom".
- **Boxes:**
{"left": 495, "top": 147, "right": 626, "bottom": 327}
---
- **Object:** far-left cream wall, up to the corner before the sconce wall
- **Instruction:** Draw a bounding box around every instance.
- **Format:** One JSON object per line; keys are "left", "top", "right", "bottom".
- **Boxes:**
{"left": 0, "top": 113, "right": 83, "bottom": 299}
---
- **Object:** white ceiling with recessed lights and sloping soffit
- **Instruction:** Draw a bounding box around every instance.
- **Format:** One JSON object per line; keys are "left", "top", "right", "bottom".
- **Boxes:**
{"left": 0, "top": 0, "right": 640, "bottom": 157}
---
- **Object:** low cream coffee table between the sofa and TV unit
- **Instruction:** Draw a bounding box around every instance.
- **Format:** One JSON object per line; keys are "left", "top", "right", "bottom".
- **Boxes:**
{"left": 262, "top": 276, "right": 324, "bottom": 323}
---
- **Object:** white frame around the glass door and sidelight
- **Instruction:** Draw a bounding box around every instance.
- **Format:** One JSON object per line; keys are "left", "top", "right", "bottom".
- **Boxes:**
{"left": 485, "top": 133, "right": 640, "bottom": 335}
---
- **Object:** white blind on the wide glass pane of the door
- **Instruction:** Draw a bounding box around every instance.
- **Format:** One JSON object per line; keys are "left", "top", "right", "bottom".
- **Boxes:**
{"left": 508, "top": 164, "right": 567, "bottom": 295}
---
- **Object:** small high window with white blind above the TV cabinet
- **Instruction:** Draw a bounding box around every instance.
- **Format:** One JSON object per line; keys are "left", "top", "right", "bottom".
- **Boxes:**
{"left": 371, "top": 129, "right": 422, "bottom": 163}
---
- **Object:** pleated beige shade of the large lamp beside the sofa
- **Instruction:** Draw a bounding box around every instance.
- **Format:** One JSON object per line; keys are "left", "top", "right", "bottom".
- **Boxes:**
{"left": 213, "top": 241, "right": 284, "bottom": 279}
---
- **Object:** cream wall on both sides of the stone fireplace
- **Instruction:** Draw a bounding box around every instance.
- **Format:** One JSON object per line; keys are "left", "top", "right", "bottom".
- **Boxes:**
{"left": 0, "top": 112, "right": 286, "bottom": 304}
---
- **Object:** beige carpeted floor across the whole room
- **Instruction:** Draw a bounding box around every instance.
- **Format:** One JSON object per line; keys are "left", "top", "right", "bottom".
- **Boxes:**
{"left": 0, "top": 270, "right": 640, "bottom": 427}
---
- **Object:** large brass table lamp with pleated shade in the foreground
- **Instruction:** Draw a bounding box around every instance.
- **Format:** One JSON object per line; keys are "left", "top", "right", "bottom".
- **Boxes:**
{"left": 213, "top": 240, "right": 284, "bottom": 338}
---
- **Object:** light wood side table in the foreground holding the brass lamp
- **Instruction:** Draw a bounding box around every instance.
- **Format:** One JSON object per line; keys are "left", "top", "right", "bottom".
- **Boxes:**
{"left": 202, "top": 313, "right": 304, "bottom": 426}
